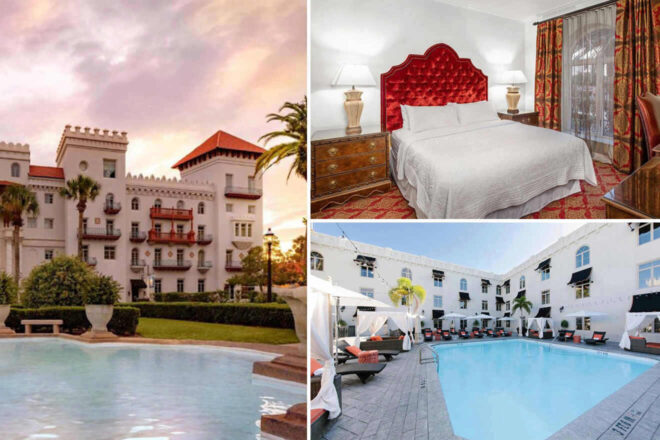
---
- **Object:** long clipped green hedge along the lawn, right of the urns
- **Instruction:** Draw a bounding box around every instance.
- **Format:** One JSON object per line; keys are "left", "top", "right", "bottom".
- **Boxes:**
{"left": 131, "top": 302, "right": 294, "bottom": 328}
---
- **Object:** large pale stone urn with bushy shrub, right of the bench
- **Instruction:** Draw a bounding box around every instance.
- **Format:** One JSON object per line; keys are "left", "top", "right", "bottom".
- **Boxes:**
{"left": 83, "top": 275, "right": 121, "bottom": 339}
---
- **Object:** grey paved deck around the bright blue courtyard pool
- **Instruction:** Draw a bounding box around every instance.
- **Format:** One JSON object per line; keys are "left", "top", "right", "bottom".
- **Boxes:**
{"left": 323, "top": 337, "right": 660, "bottom": 440}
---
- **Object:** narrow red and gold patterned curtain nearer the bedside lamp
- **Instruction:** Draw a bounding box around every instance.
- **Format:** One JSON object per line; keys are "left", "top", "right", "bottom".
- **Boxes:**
{"left": 534, "top": 18, "right": 563, "bottom": 130}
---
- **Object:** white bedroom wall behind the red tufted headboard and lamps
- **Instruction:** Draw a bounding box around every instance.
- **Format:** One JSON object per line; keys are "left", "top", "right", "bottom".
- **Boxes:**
{"left": 310, "top": 0, "right": 533, "bottom": 132}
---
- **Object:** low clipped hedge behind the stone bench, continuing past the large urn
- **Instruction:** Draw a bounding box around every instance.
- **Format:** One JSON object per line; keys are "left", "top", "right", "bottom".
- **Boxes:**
{"left": 6, "top": 306, "right": 140, "bottom": 336}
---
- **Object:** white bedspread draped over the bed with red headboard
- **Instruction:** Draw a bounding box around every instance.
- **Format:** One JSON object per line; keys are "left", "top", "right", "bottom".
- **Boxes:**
{"left": 393, "top": 121, "right": 597, "bottom": 218}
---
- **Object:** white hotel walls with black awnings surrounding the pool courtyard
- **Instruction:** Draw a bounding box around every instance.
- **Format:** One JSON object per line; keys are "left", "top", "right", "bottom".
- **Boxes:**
{"left": 310, "top": 222, "right": 660, "bottom": 342}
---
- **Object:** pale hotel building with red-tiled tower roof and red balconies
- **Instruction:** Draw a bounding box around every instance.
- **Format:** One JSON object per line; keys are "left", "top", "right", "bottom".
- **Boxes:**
{"left": 0, "top": 125, "right": 264, "bottom": 301}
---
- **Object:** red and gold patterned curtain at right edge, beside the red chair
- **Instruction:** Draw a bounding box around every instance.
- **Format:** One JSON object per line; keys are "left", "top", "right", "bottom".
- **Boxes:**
{"left": 613, "top": 0, "right": 660, "bottom": 173}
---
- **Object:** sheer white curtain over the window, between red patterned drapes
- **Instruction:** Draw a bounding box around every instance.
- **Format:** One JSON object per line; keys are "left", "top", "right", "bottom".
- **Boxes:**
{"left": 561, "top": 4, "right": 616, "bottom": 163}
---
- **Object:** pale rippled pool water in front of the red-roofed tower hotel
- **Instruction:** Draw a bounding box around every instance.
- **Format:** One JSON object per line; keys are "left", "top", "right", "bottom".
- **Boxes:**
{"left": 0, "top": 339, "right": 305, "bottom": 440}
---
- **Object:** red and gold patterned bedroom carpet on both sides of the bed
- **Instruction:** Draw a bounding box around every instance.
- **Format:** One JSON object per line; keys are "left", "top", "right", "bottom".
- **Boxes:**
{"left": 312, "top": 162, "right": 626, "bottom": 219}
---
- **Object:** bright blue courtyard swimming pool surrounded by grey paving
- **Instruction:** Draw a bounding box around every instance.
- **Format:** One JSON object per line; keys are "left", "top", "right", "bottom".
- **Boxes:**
{"left": 429, "top": 340, "right": 655, "bottom": 440}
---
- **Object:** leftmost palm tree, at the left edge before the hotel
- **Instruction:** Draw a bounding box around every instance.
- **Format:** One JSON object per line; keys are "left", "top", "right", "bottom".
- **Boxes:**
{"left": 0, "top": 184, "right": 39, "bottom": 284}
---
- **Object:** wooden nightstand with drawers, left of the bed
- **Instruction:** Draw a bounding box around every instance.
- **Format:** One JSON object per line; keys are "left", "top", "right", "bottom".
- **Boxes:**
{"left": 311, "top": 127, "right": 390, "bottom": 212}
